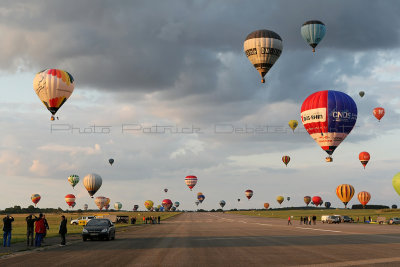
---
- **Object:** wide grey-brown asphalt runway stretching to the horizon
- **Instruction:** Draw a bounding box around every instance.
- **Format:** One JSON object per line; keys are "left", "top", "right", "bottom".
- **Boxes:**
{"left": 0, "top": 212, "right": 400, "bottom": 266}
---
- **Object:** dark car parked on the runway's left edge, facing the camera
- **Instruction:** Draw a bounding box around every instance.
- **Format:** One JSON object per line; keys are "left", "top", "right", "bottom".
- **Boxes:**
{"left": 82, "top": 219, "right": 115, "bottom": 241}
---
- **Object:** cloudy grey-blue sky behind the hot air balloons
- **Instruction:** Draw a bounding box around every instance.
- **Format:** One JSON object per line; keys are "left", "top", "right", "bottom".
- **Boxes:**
{"left": 0, "top": 0, "right": 400, "bottom": 213}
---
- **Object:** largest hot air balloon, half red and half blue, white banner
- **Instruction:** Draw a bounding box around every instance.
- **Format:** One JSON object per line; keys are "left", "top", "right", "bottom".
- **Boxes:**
{"left": 301, "top": 90, "right": 357, "bottom": 162}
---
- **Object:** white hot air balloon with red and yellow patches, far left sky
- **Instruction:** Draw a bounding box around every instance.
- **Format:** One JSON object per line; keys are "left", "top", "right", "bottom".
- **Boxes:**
{"left": 33, "top": 69, "right": 74, "bottom": 120}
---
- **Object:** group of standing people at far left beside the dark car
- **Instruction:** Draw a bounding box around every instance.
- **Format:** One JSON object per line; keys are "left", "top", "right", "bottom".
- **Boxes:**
{"left": 3, "top": 213, "right": 67, "bottom": 247}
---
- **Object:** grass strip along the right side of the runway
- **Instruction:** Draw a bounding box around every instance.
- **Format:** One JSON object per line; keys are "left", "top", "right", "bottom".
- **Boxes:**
{"left": 227, "top": 208, "right": 400, "bottom": 222}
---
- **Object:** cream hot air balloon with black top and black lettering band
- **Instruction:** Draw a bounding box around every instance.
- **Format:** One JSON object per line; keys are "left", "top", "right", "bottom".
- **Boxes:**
{"left": 243, "top": 30, "right": 283, "bottom": 83}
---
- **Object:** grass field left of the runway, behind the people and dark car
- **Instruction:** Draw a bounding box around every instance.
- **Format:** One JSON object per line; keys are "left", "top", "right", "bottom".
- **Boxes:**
{"left": 0, "top": 212, "right": 180, "bottom": 244}
